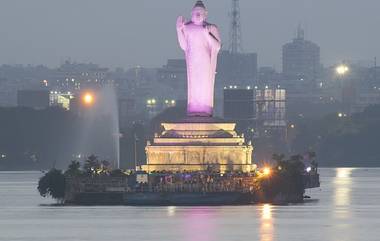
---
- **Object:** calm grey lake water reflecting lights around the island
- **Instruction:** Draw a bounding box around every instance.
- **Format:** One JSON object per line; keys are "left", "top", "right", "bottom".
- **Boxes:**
{"left": 0, "top": 168, "right": 380, "bottom": 241}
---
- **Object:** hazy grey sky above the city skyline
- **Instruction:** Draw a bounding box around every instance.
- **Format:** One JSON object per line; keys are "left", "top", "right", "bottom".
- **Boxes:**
{"left": 0, "top": 0, "right": 380, "bottom": 70}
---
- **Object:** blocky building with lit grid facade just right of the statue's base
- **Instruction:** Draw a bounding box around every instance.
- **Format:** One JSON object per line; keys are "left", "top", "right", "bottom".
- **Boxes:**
{"left": 223, "top": 86, "right": 287, "bottom": 139}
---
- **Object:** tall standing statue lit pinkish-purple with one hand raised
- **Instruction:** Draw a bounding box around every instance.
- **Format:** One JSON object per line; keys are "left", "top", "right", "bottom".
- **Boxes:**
{"left": 177, "top": 1, "right": 221, "bottom": 116}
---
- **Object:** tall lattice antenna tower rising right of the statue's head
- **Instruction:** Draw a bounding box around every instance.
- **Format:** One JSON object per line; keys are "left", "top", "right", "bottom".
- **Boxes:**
{"left": 229, "top": 0, "right": 243, "bottom": 54}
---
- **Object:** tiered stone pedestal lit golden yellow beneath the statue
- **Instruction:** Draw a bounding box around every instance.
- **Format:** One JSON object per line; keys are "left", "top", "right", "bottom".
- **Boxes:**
{"left": 142, "top": 117, "right": 256, "bottom": 173}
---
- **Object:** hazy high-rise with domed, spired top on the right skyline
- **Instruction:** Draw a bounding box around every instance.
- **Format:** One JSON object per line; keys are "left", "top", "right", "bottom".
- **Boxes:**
{"left": 282, "top": 27, "right": 322, "bottom": 81}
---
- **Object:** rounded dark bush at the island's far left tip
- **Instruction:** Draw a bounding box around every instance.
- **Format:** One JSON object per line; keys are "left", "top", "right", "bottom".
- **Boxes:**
{"left": 37, "top": 168, "right": 65, "bottom": 202}
